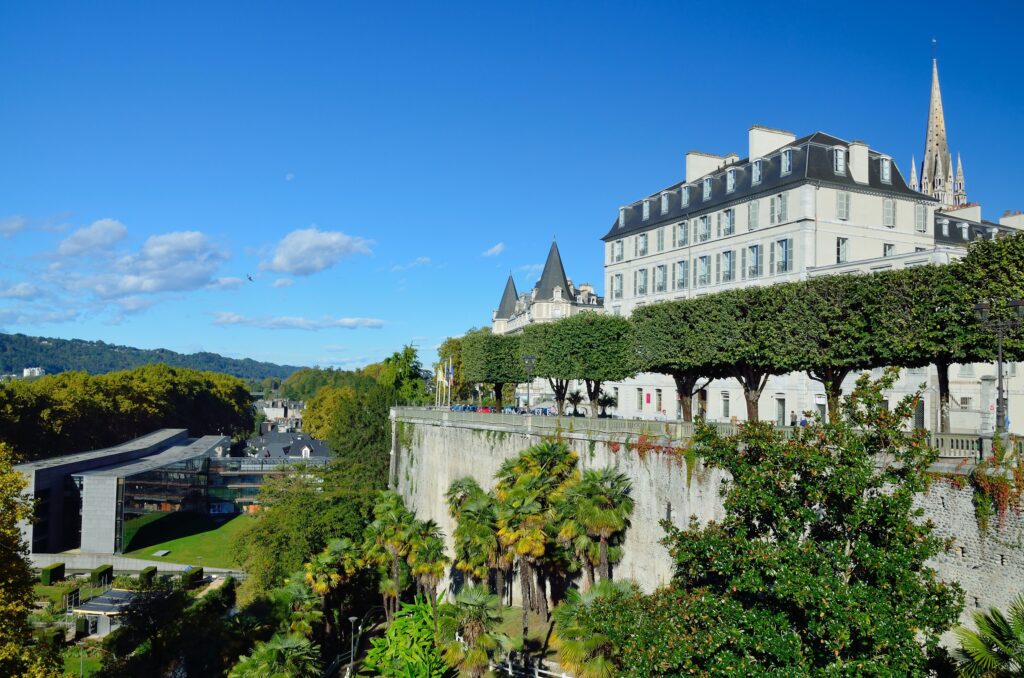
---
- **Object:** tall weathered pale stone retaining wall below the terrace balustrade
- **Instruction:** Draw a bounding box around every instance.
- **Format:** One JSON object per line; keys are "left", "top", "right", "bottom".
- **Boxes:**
{"left": 391, "top": 409, "right": 1024, "bottom": 639}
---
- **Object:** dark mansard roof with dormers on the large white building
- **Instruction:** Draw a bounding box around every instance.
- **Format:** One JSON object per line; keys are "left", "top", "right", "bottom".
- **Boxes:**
{"left": 601, "top": 132, "right": 937, "bottom": 241}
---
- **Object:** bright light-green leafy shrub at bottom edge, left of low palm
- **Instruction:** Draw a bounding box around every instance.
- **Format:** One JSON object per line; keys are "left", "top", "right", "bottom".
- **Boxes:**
{"left": 365, "top": 597, "right": 452, "bottom": 678}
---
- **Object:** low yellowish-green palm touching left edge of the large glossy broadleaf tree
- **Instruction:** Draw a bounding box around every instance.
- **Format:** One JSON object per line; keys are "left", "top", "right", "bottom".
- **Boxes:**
{"left": 553, "top": 582, "right": 637, "bottom": 678}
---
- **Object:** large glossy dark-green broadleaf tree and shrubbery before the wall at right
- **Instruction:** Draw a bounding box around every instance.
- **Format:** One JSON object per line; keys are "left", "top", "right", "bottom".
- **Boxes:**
{"left": 591, "top": 371, "right": 963, "bottom": 675}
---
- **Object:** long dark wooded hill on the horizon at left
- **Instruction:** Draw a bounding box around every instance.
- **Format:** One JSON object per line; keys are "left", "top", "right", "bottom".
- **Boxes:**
{"left": 0, "top": 333, "right": 299, "bottom": 380}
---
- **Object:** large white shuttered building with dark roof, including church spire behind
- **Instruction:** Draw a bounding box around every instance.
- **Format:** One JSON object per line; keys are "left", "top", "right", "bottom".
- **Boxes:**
{"left": 602, "top": 58, "right": 1024, "bottom": 431}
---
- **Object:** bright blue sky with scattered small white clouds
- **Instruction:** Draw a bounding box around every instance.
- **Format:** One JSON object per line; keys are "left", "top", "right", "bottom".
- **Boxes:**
{"left": 0, "top": 2, "right": 1024, "bottom": 368}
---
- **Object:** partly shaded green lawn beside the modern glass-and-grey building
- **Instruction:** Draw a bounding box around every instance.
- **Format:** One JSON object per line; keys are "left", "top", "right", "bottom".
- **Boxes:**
{"left": 124, "top": 513, "right": 256, "bottom": 567}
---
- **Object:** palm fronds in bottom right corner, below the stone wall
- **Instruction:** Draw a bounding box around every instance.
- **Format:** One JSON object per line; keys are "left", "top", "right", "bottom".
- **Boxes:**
{"left": 953, "top": 593, "right": 1024, "bottom": 678}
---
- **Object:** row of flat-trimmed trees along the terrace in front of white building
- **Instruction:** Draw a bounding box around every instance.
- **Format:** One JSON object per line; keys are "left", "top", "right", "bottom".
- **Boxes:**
{"left": 463, "top": 235, "right": 1024, "bottom": 430}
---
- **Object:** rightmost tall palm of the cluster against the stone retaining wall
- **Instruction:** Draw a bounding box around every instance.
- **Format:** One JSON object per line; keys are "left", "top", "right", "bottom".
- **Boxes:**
{"left": 570, "top": 467, "right": 633, "bottom": 580}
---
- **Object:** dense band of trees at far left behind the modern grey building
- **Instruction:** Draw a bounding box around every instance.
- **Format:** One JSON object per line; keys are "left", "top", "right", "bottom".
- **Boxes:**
{"left": 0, "top": 365, "right": 253, "bottom": 459}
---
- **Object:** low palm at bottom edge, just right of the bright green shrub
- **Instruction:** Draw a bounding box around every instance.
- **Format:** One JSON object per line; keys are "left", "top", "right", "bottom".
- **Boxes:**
{"left": 437, "top": 586, "right": 508, "bottom": 678}
